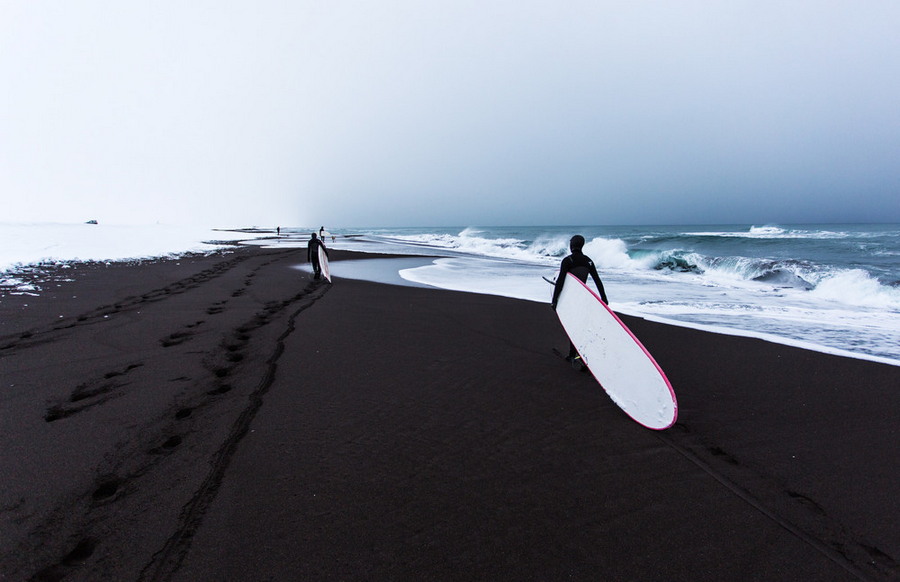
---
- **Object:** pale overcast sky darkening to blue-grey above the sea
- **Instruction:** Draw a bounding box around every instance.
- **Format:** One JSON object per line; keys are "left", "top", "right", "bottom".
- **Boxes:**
{"left": 0, "top": 0, "right": 900, "bottom": 228}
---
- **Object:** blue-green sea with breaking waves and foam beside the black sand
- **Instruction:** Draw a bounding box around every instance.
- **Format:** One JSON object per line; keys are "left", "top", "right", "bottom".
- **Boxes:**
{"left": 278, "top": 224, "right": 900, "bottom": 365}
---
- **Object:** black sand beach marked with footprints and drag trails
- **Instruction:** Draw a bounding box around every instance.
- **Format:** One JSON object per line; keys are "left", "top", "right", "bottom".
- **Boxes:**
{"left": 0, "top": 248, "right": 900, "bottom": 581}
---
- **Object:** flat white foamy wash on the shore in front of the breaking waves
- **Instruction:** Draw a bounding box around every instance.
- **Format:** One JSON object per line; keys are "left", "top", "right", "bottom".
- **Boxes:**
{"left": 400, "top": 257, "right": 900, "bottom": 364}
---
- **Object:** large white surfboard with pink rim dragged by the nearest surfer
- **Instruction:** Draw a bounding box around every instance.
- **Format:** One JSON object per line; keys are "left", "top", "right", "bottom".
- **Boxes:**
{"left": 556, "top": 273, "right": 678, "bottom": 430}
